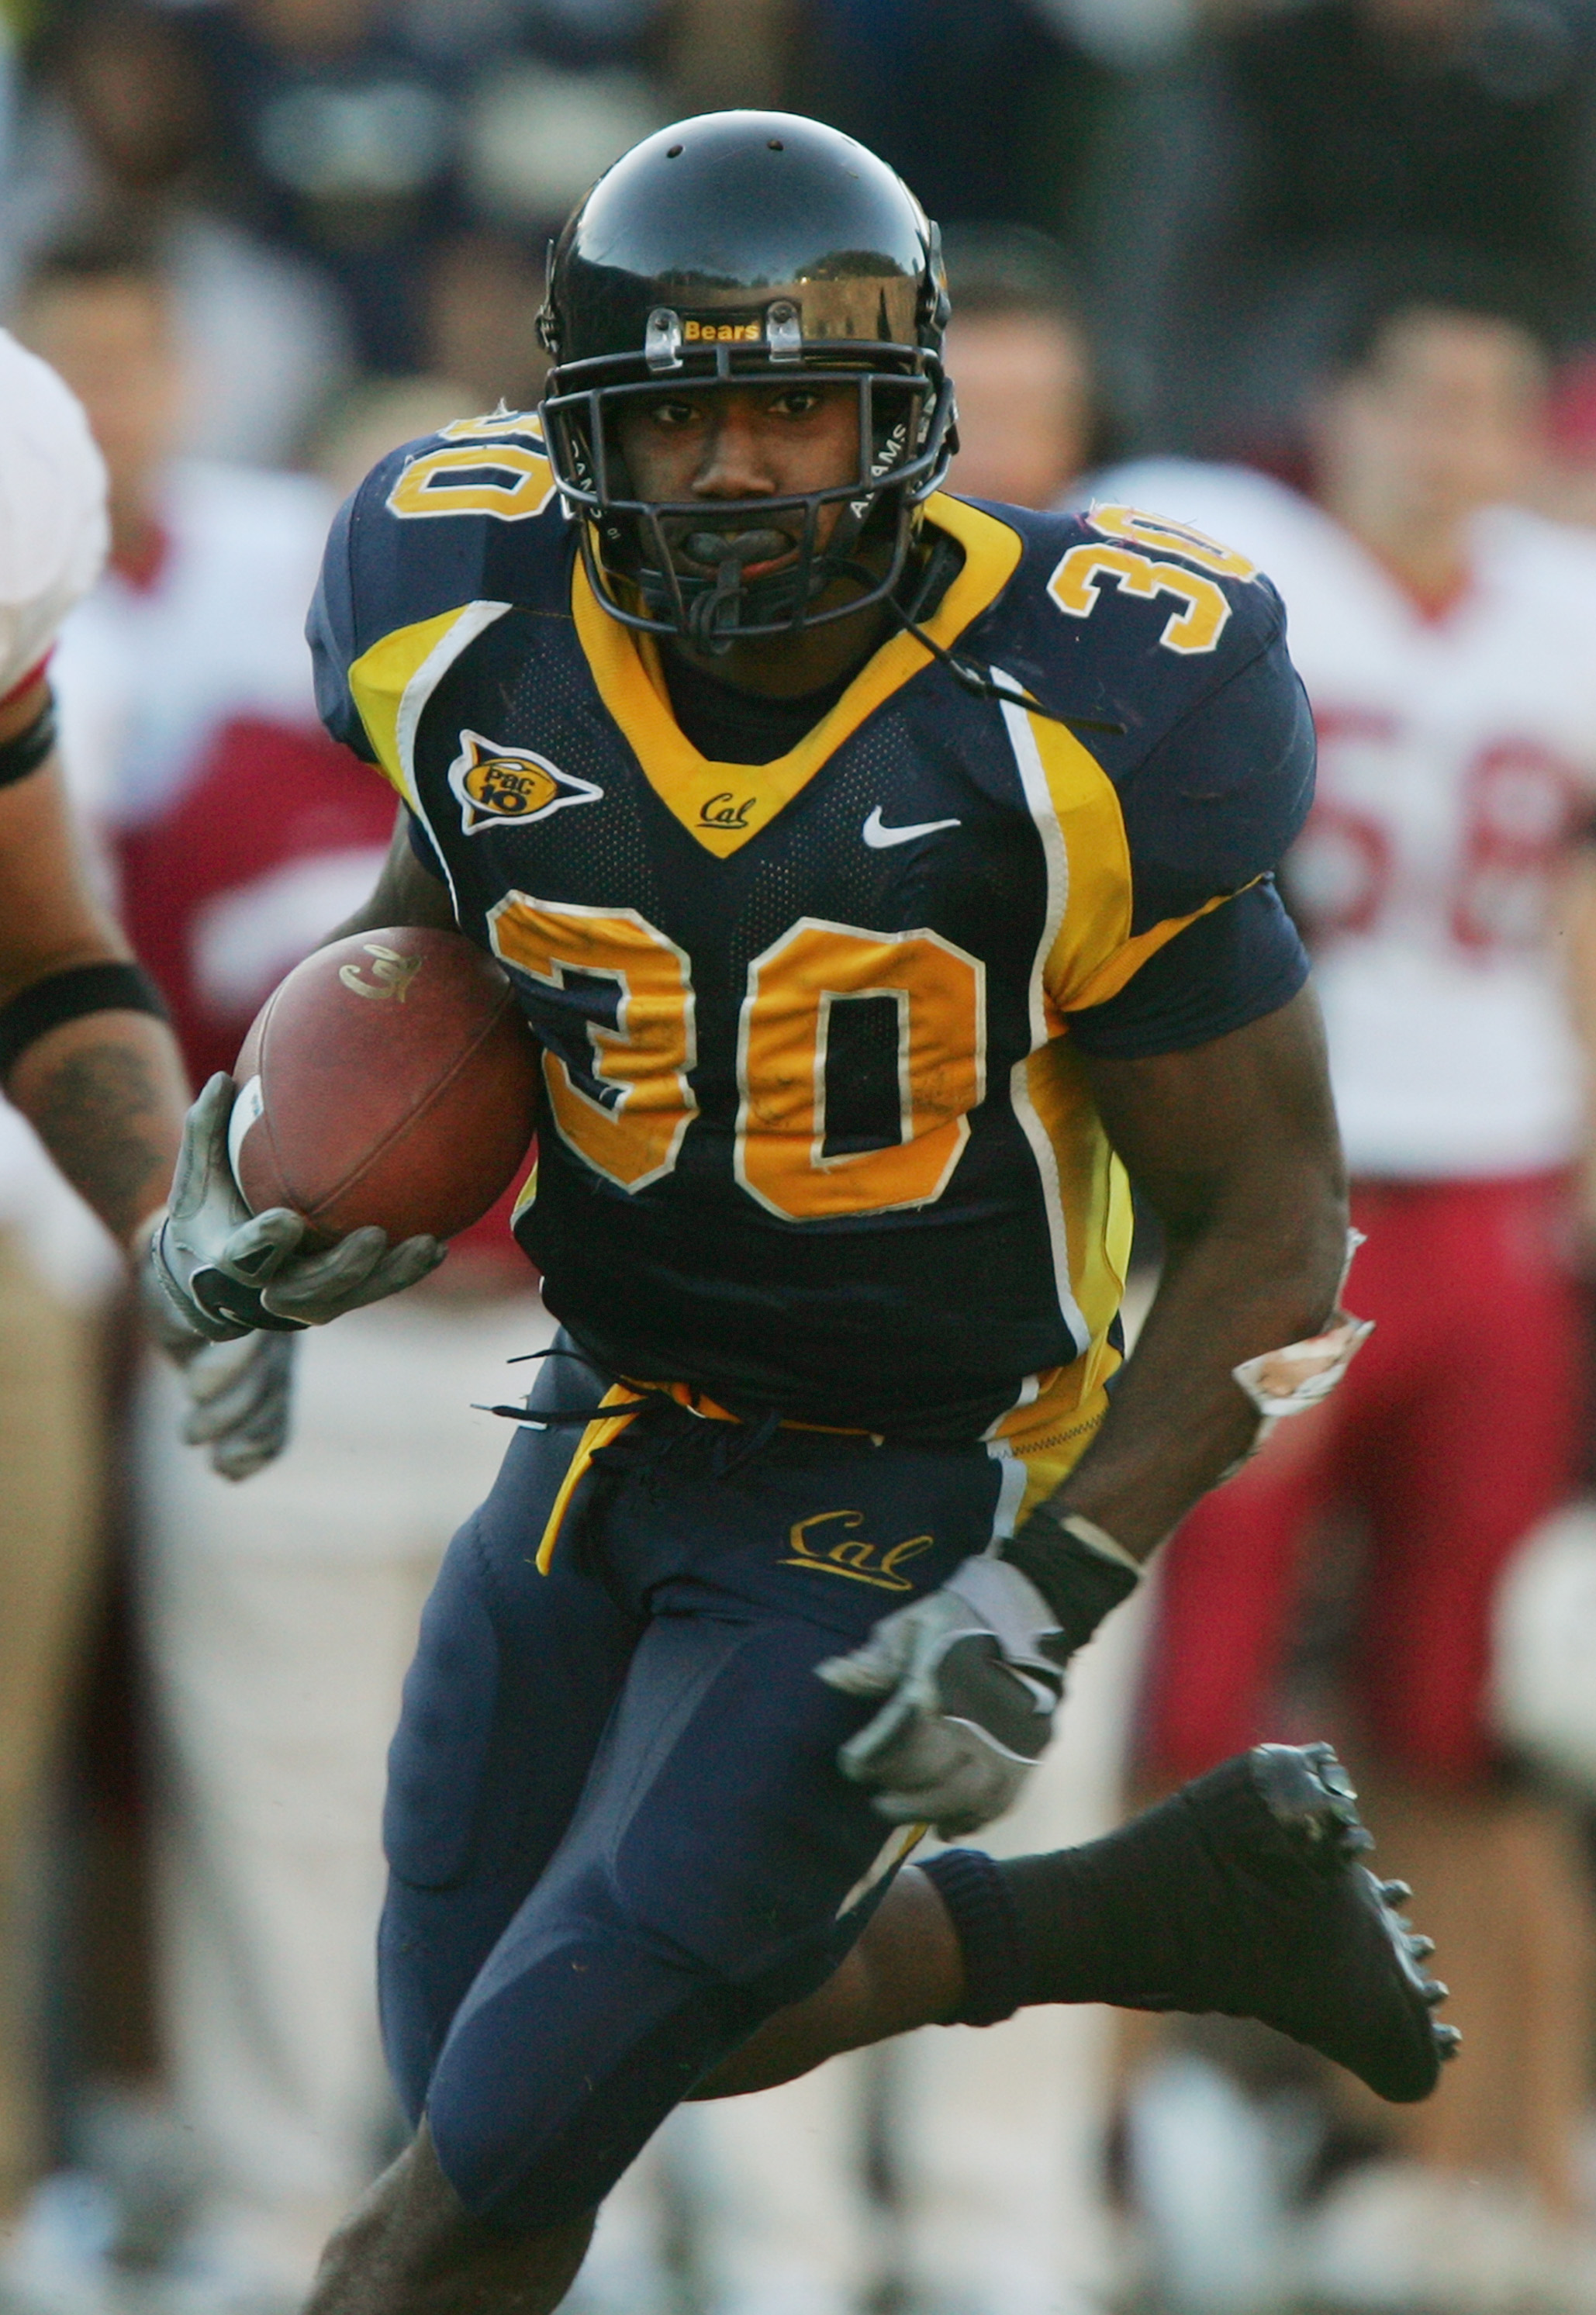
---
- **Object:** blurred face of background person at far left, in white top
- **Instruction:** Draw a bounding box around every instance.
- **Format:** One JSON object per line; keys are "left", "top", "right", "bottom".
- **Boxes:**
{"left": 19, "top": 275, "right": 183, "bottom": 517}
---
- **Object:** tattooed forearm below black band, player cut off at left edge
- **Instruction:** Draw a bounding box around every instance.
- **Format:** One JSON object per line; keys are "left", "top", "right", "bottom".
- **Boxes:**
{"left": 5, "top": 1011, "right": 188, "bottom": 1246}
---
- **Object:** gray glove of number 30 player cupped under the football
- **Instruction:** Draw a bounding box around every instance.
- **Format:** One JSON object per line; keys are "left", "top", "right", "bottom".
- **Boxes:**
{"left": 148, "top": 1072, "right": 447, "bottom": 1342}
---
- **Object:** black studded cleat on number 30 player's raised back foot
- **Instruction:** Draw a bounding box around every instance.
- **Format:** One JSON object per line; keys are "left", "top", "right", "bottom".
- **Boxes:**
{"left": 1121, "top": 1743, "right": 1462, "bottom": 2104}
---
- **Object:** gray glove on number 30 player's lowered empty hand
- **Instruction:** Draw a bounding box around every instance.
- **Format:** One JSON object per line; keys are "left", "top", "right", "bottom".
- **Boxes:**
{"left": 817, "top": 1556, "right": 1068, "bottom": 1840}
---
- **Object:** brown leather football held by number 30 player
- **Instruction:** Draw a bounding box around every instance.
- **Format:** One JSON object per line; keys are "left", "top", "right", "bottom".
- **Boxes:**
{"left": 230, "top": 926, "right": 537, "bottom": 1246}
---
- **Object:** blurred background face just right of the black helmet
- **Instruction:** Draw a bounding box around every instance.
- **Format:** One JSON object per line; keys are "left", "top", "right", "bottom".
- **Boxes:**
{"left": 948, "top": 313, "right": 1091, "bottom": 507}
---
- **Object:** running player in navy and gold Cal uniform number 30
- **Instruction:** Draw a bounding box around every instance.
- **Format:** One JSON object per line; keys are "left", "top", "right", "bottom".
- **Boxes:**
{"left": 153, "top": 113, "right": 1450, "bottom": 2315}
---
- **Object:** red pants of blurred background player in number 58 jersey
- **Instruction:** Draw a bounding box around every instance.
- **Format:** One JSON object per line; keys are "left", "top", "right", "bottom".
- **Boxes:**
{"left": 1142, "top": 1173, "right": 1582, "bottom": 1785}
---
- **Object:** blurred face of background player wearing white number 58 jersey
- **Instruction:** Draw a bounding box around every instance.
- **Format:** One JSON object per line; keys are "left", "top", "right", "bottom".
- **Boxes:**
{"left": 1318, "top": 313, "right": 1545, "bottom": 526}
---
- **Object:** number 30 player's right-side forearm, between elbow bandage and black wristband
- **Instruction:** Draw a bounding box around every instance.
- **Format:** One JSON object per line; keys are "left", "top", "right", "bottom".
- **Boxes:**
{"left": 1054, "top": 1169, "right": 1346, "bottom": 1558}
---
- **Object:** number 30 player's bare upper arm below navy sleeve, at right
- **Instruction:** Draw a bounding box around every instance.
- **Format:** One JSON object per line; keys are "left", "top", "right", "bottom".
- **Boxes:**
{"left": 1084, "top": 986, "right": 1346, "bottom": 1239}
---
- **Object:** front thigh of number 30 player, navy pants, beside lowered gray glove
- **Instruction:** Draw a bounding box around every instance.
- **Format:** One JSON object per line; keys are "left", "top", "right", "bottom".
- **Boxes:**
{"left": 416, "top": 1616, "right": 908, "bottom": 2227}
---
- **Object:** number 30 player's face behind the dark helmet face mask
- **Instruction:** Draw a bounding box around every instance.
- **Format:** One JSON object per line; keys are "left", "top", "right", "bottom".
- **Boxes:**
{"left": 617, "top": 380, "right": 859, "bottom": 579}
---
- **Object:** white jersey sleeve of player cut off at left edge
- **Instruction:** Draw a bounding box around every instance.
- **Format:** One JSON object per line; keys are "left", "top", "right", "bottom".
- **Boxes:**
{"left": 0, "top": 329, "right": 109, "bottom": 699}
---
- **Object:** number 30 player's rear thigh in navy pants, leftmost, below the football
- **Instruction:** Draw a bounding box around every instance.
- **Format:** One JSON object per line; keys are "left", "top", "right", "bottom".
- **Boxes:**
{"left": 378, "top": 1431, "right": 639, "bottom": 2118}
